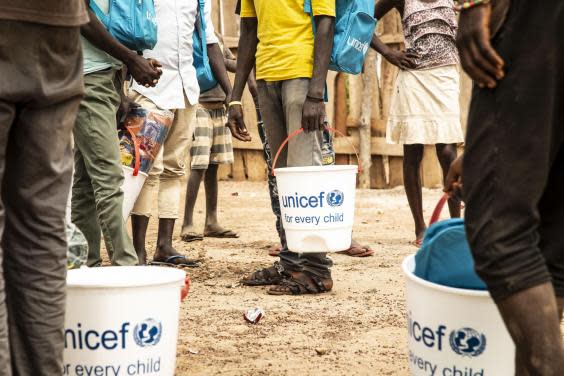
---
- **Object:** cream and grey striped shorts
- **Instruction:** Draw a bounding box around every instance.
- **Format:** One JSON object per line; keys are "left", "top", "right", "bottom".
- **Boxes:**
{"left": 190, "top": 105, "right": 233, "bottom": 170}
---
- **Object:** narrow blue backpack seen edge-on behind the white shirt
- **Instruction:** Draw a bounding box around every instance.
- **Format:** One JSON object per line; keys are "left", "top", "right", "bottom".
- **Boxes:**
{"left": 192, "top": 0, "right": 217, "bottom": 93}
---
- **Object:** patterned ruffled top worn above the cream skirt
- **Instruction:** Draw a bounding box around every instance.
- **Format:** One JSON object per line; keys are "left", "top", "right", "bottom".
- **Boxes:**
{"left": 402, "top": 0, "right": 459, "bottom": 69}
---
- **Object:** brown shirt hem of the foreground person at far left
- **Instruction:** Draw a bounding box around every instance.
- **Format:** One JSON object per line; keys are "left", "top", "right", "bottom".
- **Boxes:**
{"left": 0, "top": 0, "right": 88, "bottom": 26}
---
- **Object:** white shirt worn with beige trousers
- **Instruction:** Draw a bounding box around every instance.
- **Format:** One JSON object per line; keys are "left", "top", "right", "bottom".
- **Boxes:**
{"left": 131, "top": 0, "right": 218, "bottom": 110}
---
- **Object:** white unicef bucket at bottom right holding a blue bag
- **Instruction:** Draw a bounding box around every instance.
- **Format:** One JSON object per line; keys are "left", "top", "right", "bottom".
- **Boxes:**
{"left": 402, "top": 256, "right": 515, "bottom": 376}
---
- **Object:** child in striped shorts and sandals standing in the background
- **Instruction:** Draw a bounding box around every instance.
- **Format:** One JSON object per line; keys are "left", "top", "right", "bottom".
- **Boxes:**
{"left": 181, "top": 41, "right": 239, "bottom": 242}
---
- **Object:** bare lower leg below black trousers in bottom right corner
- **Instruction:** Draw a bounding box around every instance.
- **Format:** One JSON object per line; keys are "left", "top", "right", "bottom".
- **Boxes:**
{"left": 498, "top": 283, "right": 564, "bottom": 376}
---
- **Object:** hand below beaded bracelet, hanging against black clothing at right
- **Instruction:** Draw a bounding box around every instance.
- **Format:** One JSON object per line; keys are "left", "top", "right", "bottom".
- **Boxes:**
{"left": 456, "top": 4, "right": 505, "bottom": 89}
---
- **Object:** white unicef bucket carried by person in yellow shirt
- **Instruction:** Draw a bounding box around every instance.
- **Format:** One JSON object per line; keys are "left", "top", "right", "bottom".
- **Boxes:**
{"left": 275, "top": 165, "right": 358, "bottom": 253}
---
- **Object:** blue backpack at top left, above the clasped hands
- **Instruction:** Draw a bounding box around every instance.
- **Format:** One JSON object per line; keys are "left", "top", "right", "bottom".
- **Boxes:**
{"left": 90, "top": 0, "right": 157, "bottom": 51}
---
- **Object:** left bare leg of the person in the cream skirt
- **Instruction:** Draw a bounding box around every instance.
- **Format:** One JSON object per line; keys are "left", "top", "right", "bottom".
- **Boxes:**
{"left": 403, "top": 144, "right": 427, "bottom": 240}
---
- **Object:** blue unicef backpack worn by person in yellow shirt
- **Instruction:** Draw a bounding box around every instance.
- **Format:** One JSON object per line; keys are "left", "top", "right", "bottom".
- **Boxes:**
{"left": 304, "top": 0, "right": 376, "bottom": 74}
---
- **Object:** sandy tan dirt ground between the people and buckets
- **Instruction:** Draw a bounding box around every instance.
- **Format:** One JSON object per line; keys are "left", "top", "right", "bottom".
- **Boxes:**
{"left": 141, "top": 182, "right": 450, "bottom": 375}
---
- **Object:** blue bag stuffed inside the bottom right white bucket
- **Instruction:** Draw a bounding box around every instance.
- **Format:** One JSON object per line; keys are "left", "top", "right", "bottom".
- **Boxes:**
{"left": 414, "top": 196, "right": 487, "bottom": 290}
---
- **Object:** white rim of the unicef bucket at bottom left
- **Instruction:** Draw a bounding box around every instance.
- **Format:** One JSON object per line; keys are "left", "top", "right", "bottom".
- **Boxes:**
{"left": 67, "top": 266, "right": 186, "bottom": 289}
